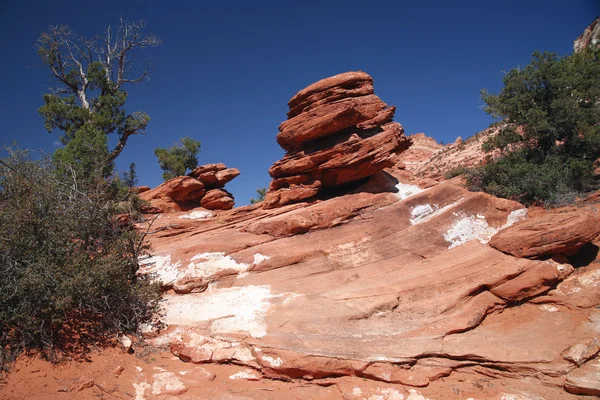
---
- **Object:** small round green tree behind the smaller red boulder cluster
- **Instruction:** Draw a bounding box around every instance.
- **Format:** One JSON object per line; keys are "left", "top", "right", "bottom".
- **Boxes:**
{"left": 154, "top": 136, "right": 200, "bottom": 181}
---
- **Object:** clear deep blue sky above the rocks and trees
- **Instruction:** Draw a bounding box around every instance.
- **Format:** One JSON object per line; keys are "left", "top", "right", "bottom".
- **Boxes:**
{"left": 0, "top": 0, "right": 600, "bottom": 206}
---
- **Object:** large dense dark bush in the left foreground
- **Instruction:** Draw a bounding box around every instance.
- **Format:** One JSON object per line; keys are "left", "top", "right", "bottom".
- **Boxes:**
{"left": 0, "top": 149, "right": 159, "bottom": 368}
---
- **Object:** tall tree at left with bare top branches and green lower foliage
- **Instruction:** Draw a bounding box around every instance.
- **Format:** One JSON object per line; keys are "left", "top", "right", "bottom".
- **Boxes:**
{"left": 36, "top": 19, "right": 160, "bottom": 184}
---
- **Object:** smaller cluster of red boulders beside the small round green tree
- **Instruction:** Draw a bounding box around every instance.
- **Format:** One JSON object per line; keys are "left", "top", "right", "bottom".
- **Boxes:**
{"left": 140, "top": 164, "right": 240, "bottom": 213}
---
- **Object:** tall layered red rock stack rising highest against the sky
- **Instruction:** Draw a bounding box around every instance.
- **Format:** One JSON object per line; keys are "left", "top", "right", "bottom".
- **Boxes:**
{"left": 264, "top": 71, "right": 410, "bottom": 208}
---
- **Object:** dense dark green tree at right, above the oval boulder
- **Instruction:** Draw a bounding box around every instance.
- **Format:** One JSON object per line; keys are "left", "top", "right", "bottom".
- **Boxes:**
{"left": 467, "top": 49, "right": 600, "bottom": 205}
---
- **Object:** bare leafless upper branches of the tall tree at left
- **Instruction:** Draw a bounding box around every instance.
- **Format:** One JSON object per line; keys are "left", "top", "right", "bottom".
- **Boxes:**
{"left": 35, "top": 17, "right": 161, "bottom": 164}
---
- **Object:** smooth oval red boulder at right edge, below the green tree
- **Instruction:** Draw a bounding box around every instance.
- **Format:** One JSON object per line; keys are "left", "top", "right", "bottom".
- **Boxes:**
{"left": 490, "top": 212, "right": 600, "bottom": 257}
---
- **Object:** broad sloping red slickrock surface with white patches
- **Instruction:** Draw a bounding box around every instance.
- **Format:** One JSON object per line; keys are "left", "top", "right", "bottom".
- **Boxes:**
{"left": 130, "top": 183, "right": 600, "bottom": 399}
